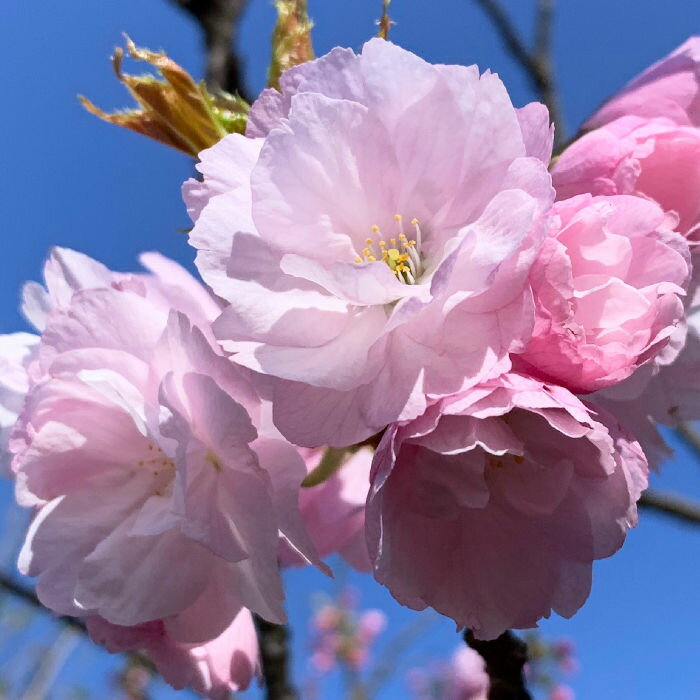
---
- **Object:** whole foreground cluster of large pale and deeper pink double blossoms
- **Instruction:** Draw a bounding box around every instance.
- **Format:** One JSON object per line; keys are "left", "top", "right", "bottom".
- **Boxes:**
{"left": 0, "top": 30, "right": 700, "bottom": 698}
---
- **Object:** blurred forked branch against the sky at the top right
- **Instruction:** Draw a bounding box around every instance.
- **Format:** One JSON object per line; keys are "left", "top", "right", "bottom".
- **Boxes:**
{"left": 474, "top": 0, "right": 565, "bottom": 148}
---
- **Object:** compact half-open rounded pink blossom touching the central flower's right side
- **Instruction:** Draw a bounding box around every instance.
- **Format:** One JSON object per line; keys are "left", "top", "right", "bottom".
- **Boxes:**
{"left": 518, "top": 195, "right": 690, "bottom": 392}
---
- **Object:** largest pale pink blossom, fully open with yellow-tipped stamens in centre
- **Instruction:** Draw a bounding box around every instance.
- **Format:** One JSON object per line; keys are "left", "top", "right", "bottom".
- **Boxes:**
{"left": 184, "top": 39, "right": 553, "bottom": 447}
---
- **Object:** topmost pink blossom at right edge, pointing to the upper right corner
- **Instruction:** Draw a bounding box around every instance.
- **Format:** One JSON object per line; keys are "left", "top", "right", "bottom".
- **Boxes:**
{"left": 585, "top": 36, "right": 700, "bottom": 128}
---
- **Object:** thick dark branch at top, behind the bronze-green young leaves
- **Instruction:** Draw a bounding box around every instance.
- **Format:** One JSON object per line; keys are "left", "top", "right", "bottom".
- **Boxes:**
{"left": 171, "top": 0, "right": 250, "bottom": 102}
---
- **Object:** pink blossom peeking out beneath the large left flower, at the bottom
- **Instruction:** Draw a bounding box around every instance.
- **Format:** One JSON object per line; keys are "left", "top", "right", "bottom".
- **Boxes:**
{"left": 86, "top": 608, "right": 260, "bottom": 700}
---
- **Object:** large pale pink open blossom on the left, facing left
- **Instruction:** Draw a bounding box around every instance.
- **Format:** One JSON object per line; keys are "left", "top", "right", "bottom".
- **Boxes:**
{"left": 11, "top": 249, "right": 322, "bottom": 644}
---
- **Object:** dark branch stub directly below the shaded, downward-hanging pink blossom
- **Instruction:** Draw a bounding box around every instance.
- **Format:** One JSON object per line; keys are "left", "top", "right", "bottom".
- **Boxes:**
{"left": 464, "top": 631, "right": 531, "bottom": 700}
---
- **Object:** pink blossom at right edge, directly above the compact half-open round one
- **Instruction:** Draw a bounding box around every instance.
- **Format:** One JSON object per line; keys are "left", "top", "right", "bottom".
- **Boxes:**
{"left": 552, "top": 116, "right": 700, "bottom": 242}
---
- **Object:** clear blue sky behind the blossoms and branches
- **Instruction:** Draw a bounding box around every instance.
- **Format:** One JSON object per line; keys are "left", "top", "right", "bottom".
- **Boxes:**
{"left": 0, "top": 0, "right": 700, "bottom": 700}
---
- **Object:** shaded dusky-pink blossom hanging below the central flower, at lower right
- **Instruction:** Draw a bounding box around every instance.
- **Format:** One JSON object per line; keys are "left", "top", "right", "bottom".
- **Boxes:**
{"left": 367, "top": 374, "right": 647, "bottom": 639}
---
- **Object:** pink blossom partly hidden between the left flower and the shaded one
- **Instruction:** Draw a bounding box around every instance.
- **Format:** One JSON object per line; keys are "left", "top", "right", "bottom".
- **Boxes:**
{"left": 281, "top": 447, "right": 373, "bottom": 571}
